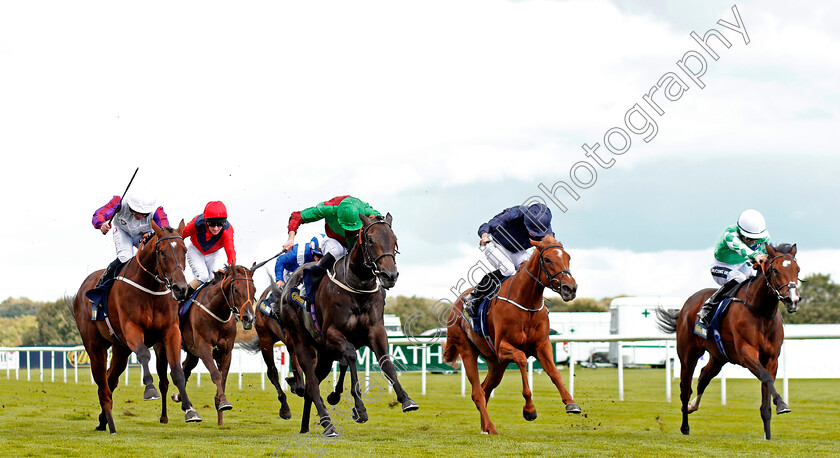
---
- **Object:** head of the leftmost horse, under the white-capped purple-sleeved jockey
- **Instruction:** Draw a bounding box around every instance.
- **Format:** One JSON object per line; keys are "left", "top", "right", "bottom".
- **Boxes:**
{"left": 152, "top": 220, "right": 187, "bottom": 301}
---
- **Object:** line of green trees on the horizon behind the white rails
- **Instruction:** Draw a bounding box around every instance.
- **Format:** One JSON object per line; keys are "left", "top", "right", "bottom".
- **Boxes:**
{"left": 0, "top": 274, "right": 840, "bottom": 347}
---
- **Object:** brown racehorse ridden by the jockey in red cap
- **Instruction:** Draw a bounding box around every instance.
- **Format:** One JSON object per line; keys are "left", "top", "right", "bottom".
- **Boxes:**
{"left": 155, "top": 266, "right": 256, "bottom": 426}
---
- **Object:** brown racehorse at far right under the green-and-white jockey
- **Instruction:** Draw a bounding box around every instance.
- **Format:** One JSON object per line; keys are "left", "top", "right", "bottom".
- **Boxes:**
{"left": 656, "top": 244, "right": 800, "bottom": 440}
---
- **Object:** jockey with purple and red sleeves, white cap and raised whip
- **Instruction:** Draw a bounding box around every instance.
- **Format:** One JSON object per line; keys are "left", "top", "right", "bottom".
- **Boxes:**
{"left": 93, "top": 192, "right": 169, "bottom": 287}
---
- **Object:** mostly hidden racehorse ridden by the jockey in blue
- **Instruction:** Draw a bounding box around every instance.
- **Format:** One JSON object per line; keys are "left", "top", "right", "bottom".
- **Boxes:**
{"left": 240, "top": 286, "right": 303, "bottom": 420}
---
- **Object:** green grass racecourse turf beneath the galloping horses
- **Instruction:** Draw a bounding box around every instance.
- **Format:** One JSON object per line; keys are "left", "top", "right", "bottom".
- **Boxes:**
{"left": 0, "top": 368, "right": 840, "bottom": 457}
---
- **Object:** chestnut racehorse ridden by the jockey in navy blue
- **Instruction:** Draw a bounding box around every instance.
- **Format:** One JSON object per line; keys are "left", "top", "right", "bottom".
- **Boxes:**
{"left": 443, "top": 235, "right": 580, "bottom": 434}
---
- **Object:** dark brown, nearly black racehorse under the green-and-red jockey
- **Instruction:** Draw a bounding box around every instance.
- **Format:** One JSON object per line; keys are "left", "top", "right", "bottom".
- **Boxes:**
{"left": 273, "top": 213, "right": 419, "bottom": 437}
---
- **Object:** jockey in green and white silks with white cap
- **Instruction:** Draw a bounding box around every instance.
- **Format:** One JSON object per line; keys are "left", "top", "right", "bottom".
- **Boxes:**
{"left": 697, "top": 209, "right": 770, "bottom": 327}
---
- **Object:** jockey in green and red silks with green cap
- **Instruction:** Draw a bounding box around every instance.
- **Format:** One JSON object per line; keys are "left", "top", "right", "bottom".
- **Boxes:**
{"left": 283, "top": 196, "right": 380, "bottom": 269}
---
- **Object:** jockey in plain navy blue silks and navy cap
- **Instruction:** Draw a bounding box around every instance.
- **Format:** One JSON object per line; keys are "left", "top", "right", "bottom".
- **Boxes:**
{"left": 464, "top": 203, "right": 554, "bottom": 316}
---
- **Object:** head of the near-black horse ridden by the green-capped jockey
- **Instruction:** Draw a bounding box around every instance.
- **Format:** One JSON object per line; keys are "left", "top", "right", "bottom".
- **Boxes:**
{"left": 359, "top": 213, "right": 400, "bottom": 289}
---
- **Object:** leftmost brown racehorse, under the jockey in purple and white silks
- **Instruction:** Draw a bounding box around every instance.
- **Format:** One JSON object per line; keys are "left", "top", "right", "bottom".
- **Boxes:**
{"left": 73, "top": 220, "right": 201, "bottom": 434}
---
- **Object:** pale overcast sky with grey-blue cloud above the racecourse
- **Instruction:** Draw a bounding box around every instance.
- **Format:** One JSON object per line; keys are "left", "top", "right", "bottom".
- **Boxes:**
{"left": 0, "top": 0, "right": 840, "bottom": 306}
